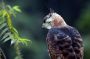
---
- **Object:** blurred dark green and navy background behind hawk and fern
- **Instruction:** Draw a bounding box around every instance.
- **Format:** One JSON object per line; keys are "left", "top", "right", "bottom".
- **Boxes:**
{"left": 0, "top": 0, "right": 90, "bottom": 59}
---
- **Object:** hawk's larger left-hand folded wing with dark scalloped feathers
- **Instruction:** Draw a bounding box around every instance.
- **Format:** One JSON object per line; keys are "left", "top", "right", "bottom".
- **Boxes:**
{"left": 47, "top": 28, "right": 76, "bottom": 59}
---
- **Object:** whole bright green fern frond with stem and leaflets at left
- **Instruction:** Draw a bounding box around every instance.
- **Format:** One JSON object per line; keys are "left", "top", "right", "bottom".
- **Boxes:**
{"left": 0, "top": 2, "right": 31, "bottom": 59}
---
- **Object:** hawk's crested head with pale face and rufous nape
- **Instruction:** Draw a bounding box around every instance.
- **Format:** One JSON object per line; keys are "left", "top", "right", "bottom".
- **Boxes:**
{"left": 42, "top": 10, "right": 67, "bottom": 29}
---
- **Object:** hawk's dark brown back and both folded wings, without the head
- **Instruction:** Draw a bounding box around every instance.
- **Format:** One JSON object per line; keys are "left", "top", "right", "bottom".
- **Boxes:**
{"left": 47, "top": 28, "right": 83, "bottom": 59}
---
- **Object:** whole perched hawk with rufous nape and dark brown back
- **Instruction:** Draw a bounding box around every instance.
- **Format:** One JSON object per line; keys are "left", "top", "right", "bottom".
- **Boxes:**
{"left": 42, "top": 11, "right": 83, "bottom": 59}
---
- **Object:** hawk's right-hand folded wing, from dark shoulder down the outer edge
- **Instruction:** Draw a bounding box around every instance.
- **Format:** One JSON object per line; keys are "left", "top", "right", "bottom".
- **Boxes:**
{"left": 62, "top": 26, "right": 84, "bottom": 59}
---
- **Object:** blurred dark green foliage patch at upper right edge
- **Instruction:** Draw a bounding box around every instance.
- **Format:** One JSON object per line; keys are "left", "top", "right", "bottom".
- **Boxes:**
{"left": 76, "top": 4, "right": 90, "bottom": 33}
